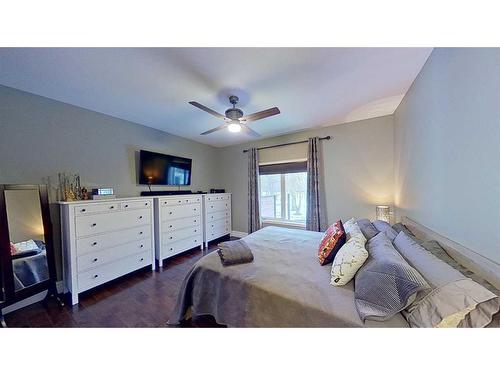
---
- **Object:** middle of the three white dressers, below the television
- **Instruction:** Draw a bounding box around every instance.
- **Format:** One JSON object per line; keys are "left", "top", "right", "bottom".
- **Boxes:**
{"left": 154, "top": 194, "right": 203, "bottom": 266}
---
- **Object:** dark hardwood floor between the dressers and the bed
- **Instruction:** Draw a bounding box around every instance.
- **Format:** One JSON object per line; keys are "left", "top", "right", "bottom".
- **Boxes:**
{"left": 5, "top": 239, "right": 231, "bottom": 327}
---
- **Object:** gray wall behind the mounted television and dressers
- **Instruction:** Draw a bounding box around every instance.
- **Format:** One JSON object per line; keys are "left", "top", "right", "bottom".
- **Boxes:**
{"left": 0, "top": 86, "right": 218, "bottom": 278}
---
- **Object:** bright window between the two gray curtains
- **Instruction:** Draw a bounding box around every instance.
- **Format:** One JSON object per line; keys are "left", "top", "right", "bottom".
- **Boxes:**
{"left": 259, "top": 162, "right": 307, "bottom": 224}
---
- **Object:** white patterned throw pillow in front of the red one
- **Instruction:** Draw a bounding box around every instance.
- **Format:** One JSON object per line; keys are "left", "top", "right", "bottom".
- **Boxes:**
{"left": 330, "top": 224, "right": 368, "bottom": 286}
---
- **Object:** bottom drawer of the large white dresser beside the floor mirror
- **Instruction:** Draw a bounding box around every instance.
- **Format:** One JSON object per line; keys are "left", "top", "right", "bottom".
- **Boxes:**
{"left": 78, "top": 251, "right": 152, "bottom": 292}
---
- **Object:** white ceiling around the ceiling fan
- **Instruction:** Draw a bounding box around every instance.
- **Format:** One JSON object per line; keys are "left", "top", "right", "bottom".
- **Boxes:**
{"left": 0, "top": 48, "right": 432, "bottom": 147}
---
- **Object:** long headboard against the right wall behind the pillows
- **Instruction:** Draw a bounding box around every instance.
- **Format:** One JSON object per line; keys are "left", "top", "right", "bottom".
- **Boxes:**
{"left": 401, "top": 216, "right": 500, "bottom": 289}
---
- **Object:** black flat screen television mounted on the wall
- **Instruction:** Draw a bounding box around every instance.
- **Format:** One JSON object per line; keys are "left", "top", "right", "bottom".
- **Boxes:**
{"left": 139, "top": 150, "right": 192, "bottom": 186}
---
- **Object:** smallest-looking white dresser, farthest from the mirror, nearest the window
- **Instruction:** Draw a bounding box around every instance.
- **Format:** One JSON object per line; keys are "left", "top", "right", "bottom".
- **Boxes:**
{"left": 203, "top": 193, "right": 231, "bottom": 248}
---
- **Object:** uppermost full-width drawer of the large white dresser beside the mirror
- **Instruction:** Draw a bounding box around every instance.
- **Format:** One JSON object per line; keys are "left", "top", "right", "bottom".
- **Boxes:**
{"left": 76, "top": 208, "right": 151, "bottom": 237}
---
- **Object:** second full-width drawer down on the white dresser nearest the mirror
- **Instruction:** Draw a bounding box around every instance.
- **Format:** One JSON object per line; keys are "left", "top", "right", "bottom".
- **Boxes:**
{"left": 76, "top": 225, "right": 151, "bottom": 256}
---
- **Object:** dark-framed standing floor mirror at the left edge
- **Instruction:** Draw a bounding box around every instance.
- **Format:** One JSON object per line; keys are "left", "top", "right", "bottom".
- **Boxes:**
{"left": 0, "top": 185, "right": 62, "bottom": 326}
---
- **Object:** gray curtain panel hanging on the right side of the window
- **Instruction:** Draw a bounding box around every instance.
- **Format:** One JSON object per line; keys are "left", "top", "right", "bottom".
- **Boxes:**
{"left": 306, "top": 137, "right": 324, "bottom": 232}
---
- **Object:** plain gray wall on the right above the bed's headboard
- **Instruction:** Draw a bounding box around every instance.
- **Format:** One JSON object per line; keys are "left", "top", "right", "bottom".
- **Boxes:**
{"left": 394, "top": 48, "right": 500, "bottom": 262}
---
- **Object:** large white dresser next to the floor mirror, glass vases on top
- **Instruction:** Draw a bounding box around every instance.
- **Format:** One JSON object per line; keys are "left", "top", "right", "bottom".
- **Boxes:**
{"left": 60, "top": 198, "right": 155, "bottom": 304}
